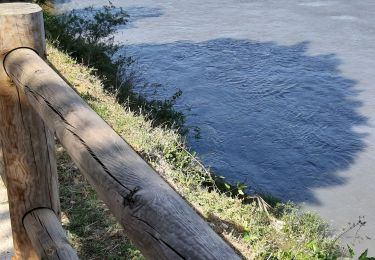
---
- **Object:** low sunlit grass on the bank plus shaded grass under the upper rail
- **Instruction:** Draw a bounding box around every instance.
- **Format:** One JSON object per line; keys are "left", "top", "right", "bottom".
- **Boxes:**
{"left": 48, "top": 43, "right": 346, "bottom": 259}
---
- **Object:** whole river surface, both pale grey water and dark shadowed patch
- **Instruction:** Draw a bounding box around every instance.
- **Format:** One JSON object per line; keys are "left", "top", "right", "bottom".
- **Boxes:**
{"left": 57, "top": 0, "right": 375, "bottom": 254}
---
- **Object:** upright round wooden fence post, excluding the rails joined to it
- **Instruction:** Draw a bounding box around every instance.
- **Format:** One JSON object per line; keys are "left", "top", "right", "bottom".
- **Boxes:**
{"left": 0, "top": 3, "right": 60, "bottom": 259}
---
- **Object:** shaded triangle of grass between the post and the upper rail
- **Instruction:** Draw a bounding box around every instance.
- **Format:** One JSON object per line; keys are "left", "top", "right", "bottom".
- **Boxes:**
{"left": 57, "top": 148, "right": 143, "bottom": 259}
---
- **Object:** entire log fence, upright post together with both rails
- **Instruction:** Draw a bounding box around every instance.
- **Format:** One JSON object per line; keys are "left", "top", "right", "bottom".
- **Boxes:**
{"left": 0, "top": 3, "right": 239, "bottom": 259}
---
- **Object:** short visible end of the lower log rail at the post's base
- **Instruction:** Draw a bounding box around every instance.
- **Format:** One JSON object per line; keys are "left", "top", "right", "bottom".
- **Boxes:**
{"left": 23, "top": 208, "right": 78, "bottom": 260}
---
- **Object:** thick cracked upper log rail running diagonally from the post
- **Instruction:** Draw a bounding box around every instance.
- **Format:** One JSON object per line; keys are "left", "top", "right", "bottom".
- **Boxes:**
{"left": 5, "top": 49, "right": 239, "bottom": 259}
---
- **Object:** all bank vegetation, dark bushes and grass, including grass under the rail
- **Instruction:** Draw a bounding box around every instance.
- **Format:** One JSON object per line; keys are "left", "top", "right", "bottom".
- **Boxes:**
{"left": 36, "top": 0, "right": 357, "bottom": 259}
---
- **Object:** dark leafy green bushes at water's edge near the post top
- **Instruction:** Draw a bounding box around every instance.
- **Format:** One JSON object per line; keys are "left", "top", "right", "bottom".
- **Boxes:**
{"left": 44, "top": 3, "right": 187, "bottom": 131}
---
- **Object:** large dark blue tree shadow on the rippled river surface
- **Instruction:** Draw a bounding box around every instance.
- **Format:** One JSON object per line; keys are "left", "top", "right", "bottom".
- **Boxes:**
{"left": 122, "top": 39, "right": 366, "bottom": 204}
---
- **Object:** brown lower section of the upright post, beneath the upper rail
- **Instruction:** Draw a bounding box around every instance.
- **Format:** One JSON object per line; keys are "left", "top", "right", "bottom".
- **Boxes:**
{"left": 0, "top": 77, "right": 60, "bottom": 259}
